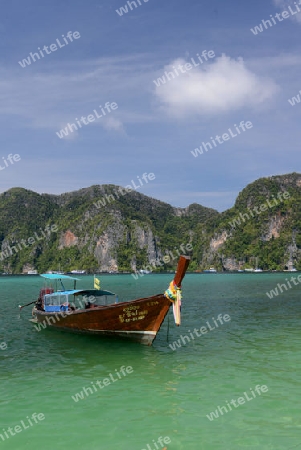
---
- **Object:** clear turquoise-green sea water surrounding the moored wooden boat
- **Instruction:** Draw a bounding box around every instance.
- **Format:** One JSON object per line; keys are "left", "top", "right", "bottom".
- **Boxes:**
{"left": 0, "top": 274, "right": 301, "bottom": 450}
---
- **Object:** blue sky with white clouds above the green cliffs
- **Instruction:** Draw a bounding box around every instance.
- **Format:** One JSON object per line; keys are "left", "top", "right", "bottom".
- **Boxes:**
{"left": 0, "top": 0, "right": 301, "bottom": 211}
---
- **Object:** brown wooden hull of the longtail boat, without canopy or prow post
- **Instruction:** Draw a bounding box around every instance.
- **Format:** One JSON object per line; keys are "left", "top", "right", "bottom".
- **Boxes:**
{"left": 35, "top": 294, "right": 171, "bottom": 345}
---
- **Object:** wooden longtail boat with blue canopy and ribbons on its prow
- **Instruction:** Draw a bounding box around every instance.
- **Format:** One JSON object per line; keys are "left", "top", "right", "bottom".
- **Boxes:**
{"left": 31, "top": 256, "right": 190, "bottom": 345}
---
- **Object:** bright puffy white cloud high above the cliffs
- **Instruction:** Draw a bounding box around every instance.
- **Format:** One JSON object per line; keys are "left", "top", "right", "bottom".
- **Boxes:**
{"left": 155, "top": 55, "right": 278, "bottom": 118}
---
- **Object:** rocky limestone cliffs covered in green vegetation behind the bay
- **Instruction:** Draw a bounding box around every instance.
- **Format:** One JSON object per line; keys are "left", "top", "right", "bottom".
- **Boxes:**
{"left": 0, "top": 173, "right": 301, "bottom": 273}
